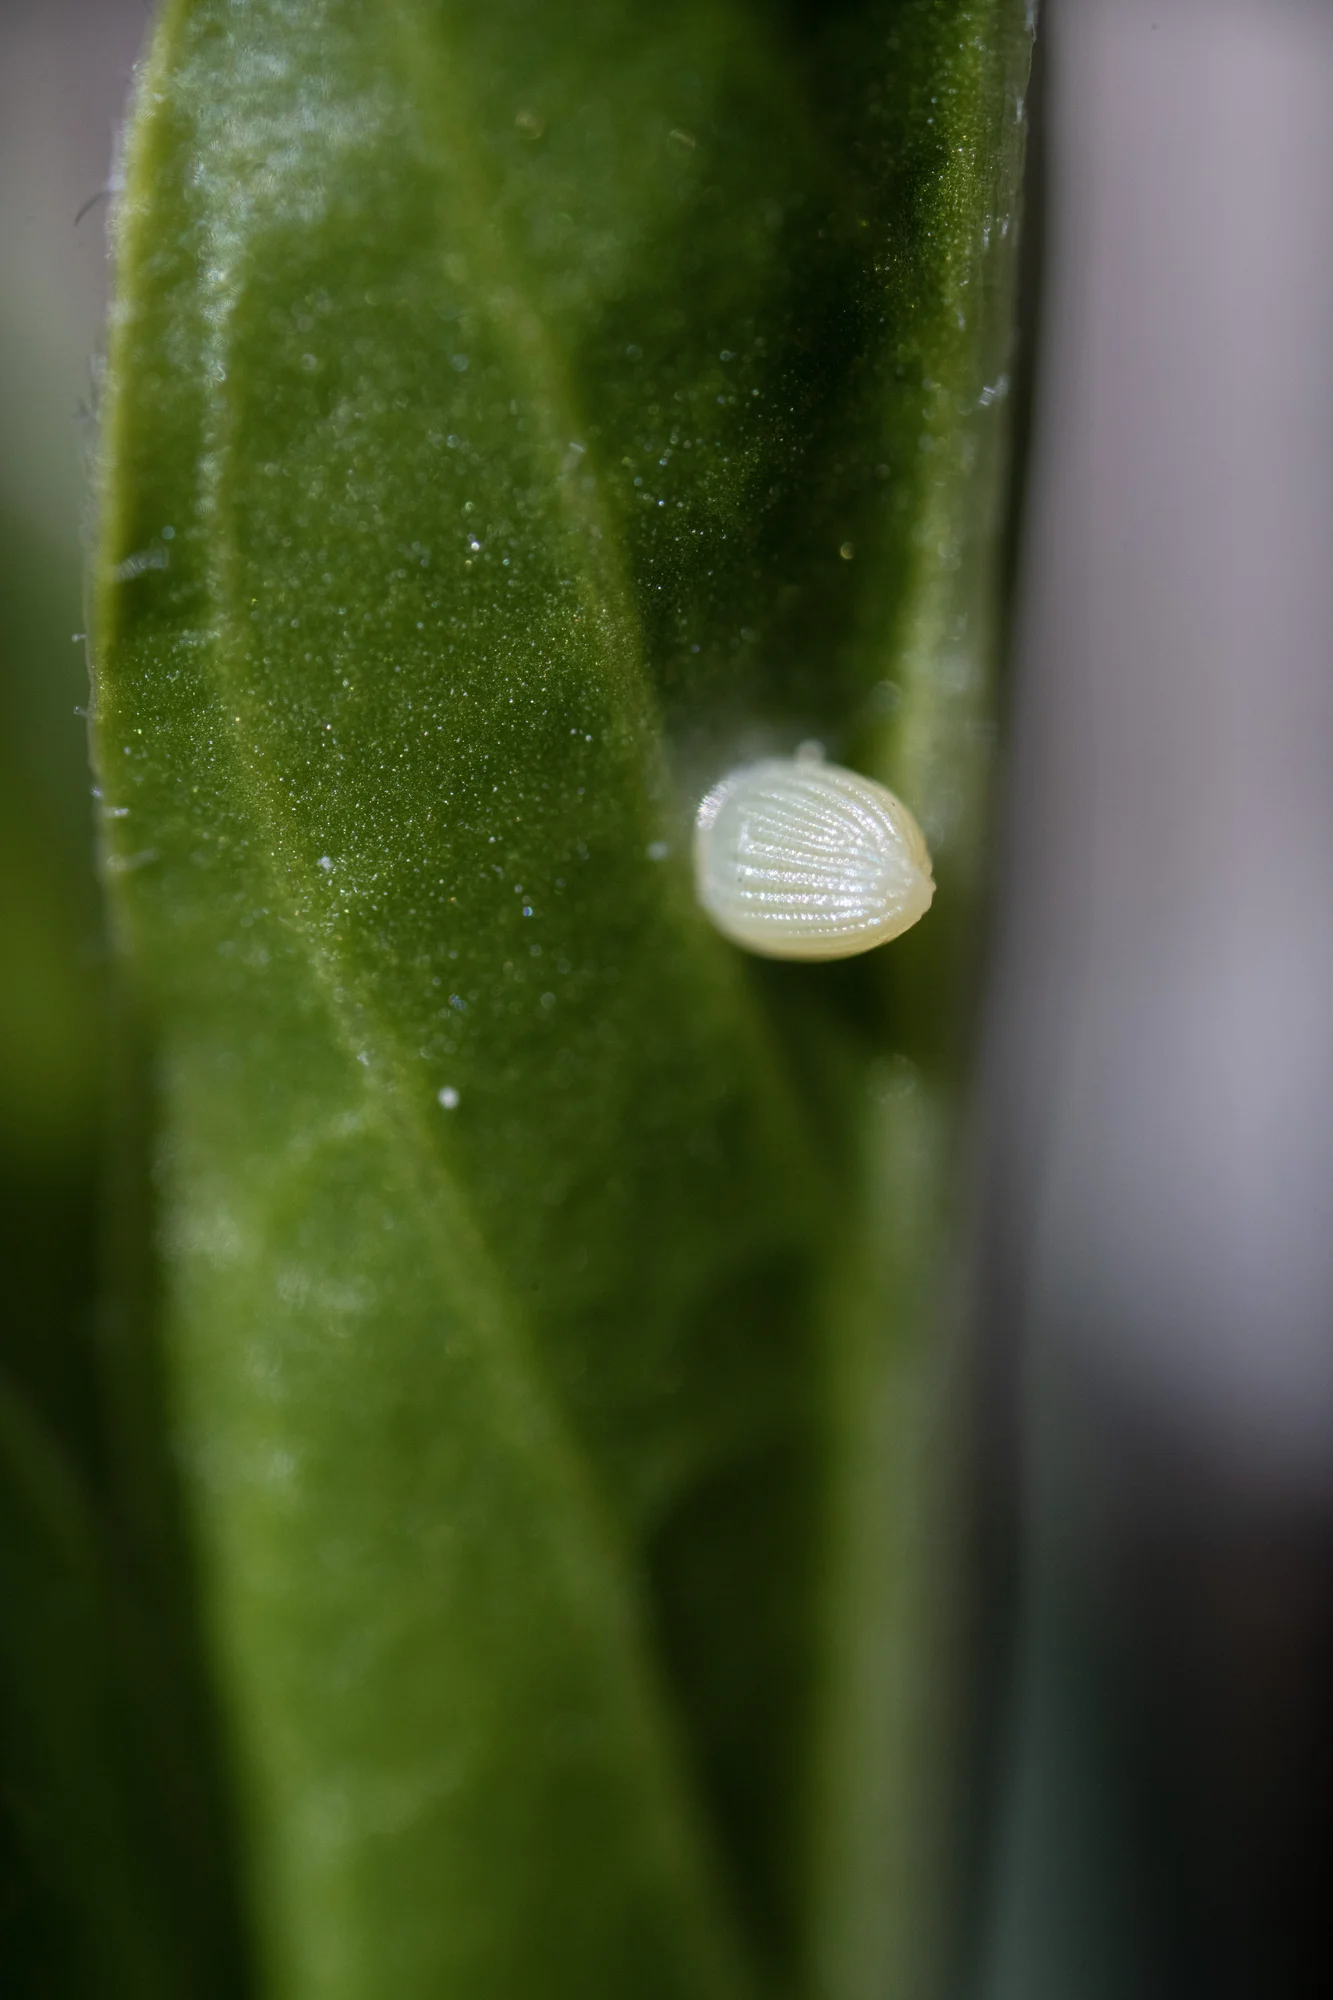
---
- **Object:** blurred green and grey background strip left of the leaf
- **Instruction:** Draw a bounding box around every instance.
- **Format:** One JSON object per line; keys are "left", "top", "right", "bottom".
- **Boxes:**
{"left": 0, "top": 11, "right": 170, "bottom": 1994}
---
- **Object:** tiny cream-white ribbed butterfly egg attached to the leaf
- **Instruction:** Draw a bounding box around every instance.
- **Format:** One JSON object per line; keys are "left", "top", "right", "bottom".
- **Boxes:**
{"left": 695, "top": 752, "right": 935, "bottom": 958}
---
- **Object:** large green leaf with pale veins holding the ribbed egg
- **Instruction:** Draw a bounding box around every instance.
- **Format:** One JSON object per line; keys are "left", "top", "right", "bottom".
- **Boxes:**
{"left": 96, "top": 0, "right": 1029, "bottom": 2000}
